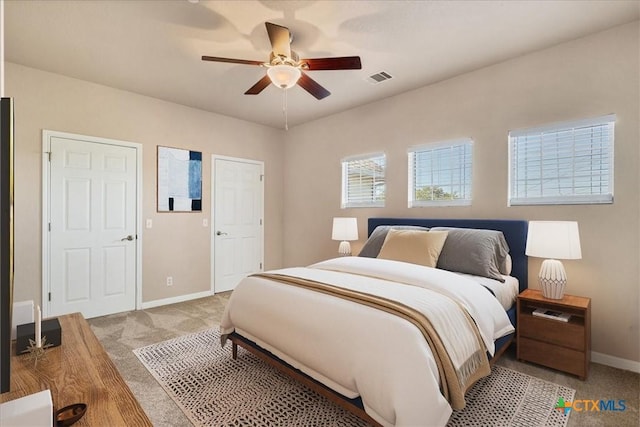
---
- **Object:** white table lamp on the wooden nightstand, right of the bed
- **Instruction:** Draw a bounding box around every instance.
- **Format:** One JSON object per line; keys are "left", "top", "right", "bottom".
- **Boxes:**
{"left": 525, "top": 221, "right": 582, "bottom": 299}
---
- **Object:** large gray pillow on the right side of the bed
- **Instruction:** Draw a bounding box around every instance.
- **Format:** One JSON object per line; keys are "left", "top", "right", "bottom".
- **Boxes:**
{"left": 431, "top": 227, "right": 509, "bottom": 282}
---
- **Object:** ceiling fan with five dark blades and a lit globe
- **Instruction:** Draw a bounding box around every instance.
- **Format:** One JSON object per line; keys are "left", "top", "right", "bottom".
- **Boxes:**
{"left": 202, "top": 22, "right": 362, "bottom": 99}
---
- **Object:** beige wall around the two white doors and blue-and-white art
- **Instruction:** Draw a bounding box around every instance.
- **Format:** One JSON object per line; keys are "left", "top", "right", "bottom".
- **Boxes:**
{"left": 5, "top": 63, "right": 283, "bottom": 302}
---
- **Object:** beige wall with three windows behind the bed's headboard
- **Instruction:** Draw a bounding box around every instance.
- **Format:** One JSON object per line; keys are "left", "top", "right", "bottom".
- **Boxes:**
{"left": 284, "top": 22, "right": 640, "bottom": 362}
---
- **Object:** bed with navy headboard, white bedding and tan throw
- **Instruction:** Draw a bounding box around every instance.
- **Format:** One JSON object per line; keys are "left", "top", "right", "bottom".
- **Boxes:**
{"left": 220, "top": 218, "right": 527, "bottom": 426}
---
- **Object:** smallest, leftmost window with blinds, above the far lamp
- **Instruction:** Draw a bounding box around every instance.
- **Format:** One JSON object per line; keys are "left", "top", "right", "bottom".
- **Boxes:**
{"left": 342, "top": 153, "right": 386, "bottom": 208}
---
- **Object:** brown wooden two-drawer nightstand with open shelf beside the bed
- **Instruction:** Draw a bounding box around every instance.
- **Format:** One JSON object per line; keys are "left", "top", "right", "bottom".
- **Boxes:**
{"left": 516, "top": 289, "right": 591, "bottom": 380}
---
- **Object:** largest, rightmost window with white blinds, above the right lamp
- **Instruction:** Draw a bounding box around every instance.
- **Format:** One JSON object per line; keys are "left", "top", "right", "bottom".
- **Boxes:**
{"left": 509, "top": 115, "right": 615, "bottom": 205}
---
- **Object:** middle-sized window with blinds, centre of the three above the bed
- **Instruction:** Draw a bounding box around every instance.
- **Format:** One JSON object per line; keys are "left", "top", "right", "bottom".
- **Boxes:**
{"left": 409, "top": 138, "right": 473, "bottom": 208}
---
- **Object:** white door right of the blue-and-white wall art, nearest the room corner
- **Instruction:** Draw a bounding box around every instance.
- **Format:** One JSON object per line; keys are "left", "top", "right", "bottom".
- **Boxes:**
{"left": 211, "top": 156, "right": 264, "bottom": 292}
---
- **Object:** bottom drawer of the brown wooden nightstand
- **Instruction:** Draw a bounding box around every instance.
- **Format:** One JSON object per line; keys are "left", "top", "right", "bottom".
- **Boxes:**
{"left": 517, "top": 337, "right": 586, "bottom": 377}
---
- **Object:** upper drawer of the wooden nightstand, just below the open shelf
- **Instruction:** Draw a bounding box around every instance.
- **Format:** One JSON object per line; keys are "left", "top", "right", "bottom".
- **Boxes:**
{"left": 518, "top": 316, "right": 585, "bottom": 351}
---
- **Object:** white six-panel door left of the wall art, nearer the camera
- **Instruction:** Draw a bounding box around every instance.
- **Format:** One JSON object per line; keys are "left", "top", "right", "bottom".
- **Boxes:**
{"left": 44, "top": 136, "right": 138, "bottom": 318}
